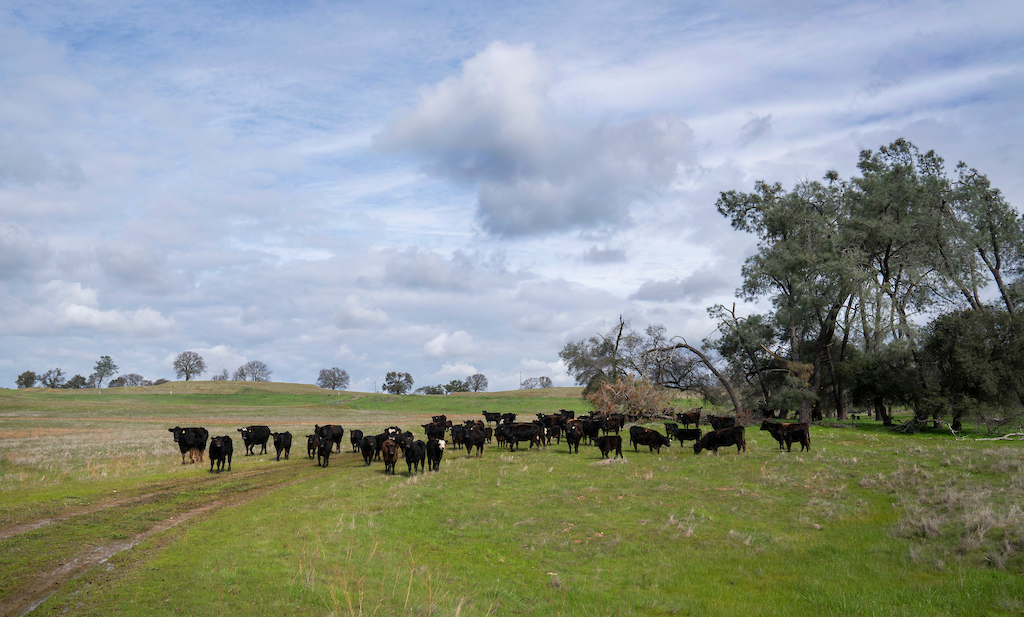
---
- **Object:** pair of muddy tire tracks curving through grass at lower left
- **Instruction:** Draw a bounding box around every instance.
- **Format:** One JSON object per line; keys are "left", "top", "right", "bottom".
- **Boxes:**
{"left": 0, "top": 468, "right": 309, "bottom": 617}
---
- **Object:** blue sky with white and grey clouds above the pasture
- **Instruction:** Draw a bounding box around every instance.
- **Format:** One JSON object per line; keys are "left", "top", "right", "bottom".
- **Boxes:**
{"left": 0, "top": 0, "right": 1024, "bottom": 392}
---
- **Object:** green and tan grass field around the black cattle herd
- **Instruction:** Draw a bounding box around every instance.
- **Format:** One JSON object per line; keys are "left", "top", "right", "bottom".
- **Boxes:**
{"left": 0, "top": 382, "right": 1024, "bottom": 617}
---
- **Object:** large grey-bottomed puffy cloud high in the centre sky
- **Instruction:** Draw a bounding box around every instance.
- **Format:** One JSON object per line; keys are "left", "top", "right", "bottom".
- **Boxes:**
{"left": 375, "top": 42, "right": 693, "bottom": 236}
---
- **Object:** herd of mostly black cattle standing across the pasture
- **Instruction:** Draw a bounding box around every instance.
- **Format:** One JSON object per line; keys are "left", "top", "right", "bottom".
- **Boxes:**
{"left": 168, "top": 409, "right": 811, "bottom": 475}
